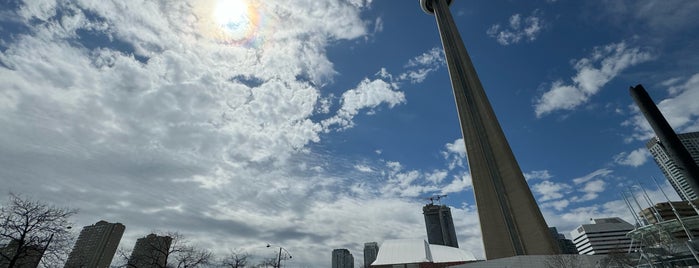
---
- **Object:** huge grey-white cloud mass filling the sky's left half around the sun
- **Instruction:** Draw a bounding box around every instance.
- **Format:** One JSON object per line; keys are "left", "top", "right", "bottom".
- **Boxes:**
{"left": 0, "top": 0, "right": 437, "bottom": 267}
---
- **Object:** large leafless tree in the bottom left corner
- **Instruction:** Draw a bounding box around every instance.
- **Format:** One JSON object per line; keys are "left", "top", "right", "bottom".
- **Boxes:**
{"left": 0, "top": 193, "right": 77, "bottom": 268}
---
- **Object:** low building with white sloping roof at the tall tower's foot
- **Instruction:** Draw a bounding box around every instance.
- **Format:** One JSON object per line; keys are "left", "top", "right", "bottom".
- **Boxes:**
{"left": 371, "top": 239, "right": 476, "bottom": 268}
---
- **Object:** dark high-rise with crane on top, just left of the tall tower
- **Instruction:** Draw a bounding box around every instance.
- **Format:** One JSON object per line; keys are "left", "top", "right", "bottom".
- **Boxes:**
{"left": 422, "top": 204, "right": 459, "bottom": 248}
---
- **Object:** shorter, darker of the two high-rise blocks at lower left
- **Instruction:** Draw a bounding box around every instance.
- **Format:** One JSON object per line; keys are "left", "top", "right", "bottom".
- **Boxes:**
{"left": 128, "top": 234, "right": 172, "bottom": 268}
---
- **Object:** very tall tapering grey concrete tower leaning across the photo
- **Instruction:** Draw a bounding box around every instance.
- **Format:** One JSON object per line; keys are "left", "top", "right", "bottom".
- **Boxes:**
{"left": 420, "top": 0, "right": 558, "bottom": 259}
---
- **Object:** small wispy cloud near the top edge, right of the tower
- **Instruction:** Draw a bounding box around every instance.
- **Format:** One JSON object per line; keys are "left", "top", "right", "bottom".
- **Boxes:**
{"left": 486, "top": 10, "right": 543, "bottom": 46}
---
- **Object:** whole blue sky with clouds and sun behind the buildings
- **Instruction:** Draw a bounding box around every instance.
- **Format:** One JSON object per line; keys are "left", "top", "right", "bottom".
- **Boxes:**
{"left": 0, "top": 0, "right": 699, "bottom": 267}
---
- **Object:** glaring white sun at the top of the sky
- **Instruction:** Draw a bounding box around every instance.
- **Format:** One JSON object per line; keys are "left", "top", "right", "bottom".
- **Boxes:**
{"left": 213, "top": 0, "right": 254, "bottom": 40}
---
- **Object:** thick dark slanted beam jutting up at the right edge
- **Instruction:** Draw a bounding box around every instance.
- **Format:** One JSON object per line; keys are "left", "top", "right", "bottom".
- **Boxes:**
{"left": 629, "top": 85, "right": 699, "bottom": 200}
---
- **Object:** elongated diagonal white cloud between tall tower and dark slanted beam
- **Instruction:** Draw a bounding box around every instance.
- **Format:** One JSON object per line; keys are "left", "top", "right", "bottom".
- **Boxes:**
{"left": 534, "top": 42, "right": 653, "bottom": 118}
